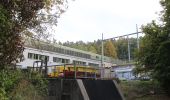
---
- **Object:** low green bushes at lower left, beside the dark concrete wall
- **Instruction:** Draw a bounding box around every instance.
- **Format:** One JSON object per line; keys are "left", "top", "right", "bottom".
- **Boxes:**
{"left": 0, "top": 70, "right": 48, "bottom": 100}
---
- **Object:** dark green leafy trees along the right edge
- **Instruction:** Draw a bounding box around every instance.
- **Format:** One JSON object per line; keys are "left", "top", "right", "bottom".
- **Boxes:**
{"left": 136, "top": 0, "right": 170, "bottom": 95}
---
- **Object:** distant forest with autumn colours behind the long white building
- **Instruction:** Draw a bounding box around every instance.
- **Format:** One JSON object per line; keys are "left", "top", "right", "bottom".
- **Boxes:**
{"left": 61, "top": 38, "right": 137, "bottom": 60}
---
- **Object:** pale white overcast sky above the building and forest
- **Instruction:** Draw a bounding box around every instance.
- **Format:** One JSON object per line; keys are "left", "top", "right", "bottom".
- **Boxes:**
{"left": 52, "top": 0, "right": 161, "bottom": 42}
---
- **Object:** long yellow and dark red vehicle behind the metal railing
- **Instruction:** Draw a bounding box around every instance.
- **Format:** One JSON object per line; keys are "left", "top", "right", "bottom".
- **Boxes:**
{"left": 47, "top": 64, "right": 100, "bottom": 79}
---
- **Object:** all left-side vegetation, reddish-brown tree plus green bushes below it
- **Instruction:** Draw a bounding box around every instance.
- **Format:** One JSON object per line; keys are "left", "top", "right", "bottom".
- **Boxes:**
{"left": 0, "top": 0, "right": 67, "bottom": 100}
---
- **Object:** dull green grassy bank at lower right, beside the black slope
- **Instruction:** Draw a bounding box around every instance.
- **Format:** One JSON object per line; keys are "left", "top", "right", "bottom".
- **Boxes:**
{"left": 119, "top": 80, "right": 170, "bottom": 100}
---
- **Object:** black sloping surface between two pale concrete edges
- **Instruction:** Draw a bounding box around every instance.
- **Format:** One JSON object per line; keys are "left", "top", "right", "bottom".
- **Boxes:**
{"left": 83, "top": 80, "right": 122, "bottom": 100}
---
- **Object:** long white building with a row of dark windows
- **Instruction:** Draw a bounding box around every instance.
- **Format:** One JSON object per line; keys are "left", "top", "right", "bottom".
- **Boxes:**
{"left": 17, "top": 40, "right": 113, "bottom": 69}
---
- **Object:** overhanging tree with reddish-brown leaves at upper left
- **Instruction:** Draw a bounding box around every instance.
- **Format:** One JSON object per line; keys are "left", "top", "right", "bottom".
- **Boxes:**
{"left": 0, "top": 0, "right": 65, "bottom": 69}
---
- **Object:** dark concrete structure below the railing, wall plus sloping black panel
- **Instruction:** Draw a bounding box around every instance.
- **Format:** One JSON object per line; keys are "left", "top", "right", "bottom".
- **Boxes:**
{"left": 48, "top": 79, "right": 124, "bottom": 100}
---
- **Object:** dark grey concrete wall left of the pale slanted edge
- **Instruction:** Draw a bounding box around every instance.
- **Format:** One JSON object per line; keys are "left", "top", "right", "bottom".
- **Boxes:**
{"left": 48, "top": 79, "right": 84, "bottom": 100}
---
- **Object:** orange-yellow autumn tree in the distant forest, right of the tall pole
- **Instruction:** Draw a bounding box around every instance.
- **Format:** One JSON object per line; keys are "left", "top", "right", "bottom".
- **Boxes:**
{"left": 104, "top": 40, "right": 117, "bottom": 58}
